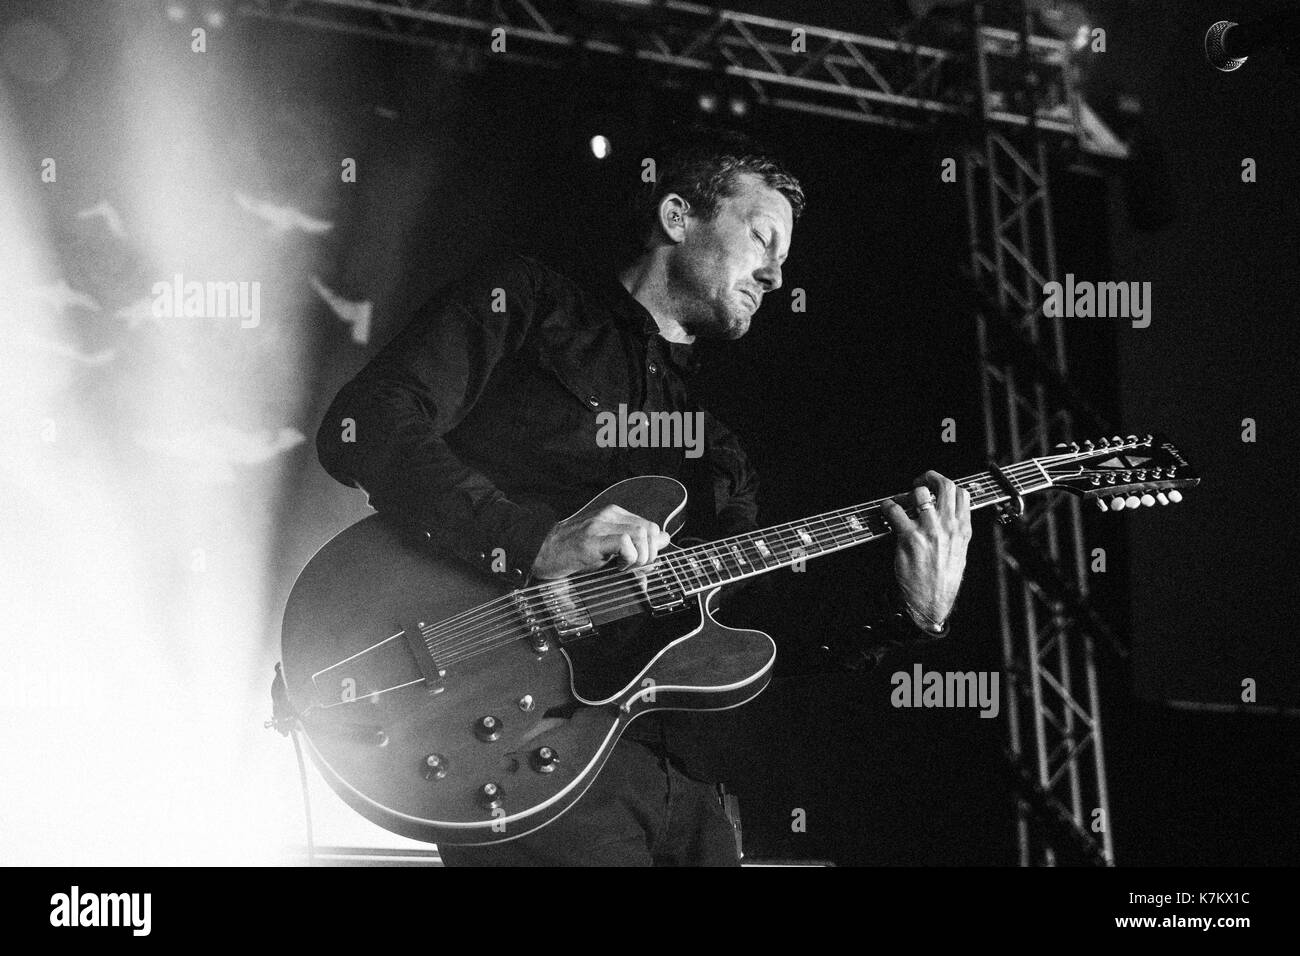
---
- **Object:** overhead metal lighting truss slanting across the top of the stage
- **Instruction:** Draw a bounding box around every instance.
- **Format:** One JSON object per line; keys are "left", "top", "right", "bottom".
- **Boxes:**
{"left": 237, "top": 0, "right": 1114, "bottom": 148}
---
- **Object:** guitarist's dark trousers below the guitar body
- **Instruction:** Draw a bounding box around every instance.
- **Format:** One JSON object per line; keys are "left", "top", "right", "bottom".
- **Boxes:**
{"left": 438, "top": 739, "right": 740, "bottom": 866}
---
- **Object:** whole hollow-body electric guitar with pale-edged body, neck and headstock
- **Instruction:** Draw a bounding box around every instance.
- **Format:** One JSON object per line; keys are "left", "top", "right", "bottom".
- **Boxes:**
{"left": 282, "top": 436, "right": 1200, "bottom": 844}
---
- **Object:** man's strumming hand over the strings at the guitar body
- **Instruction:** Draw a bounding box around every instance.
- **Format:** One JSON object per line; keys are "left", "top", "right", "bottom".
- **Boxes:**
{"left": 533, "top": 505, "right": 671, "bottom": 579}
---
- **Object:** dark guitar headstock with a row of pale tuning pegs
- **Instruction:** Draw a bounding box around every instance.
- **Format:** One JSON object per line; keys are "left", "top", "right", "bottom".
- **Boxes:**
{"left": 1035, "top": 434, "right": 1201, "bottom": 511}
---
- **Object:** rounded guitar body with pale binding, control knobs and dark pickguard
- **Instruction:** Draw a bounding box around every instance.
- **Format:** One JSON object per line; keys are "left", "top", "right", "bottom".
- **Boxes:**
{"left": 282, "top": 476, "right": 776, "bottom": 844}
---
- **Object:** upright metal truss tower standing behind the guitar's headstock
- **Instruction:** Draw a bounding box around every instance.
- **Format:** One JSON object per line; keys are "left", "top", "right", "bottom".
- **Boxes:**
{"left": 966, "top": 7, "right": 1122, "bottom": 866}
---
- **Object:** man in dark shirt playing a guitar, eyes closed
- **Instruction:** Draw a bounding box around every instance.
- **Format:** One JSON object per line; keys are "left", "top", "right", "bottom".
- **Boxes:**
{"left": 317, "top": 128, "right": 971, "bottom": 866}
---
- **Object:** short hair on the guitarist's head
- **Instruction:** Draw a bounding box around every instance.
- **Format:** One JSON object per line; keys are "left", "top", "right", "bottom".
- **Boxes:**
{"left": 634, "top": 127, "right": 805, "bottom": 243}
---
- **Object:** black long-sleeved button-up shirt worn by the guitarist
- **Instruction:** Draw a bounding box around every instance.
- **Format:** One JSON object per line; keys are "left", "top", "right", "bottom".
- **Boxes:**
{"left": 316, "top": 256, "right": 758, "bottom": 584}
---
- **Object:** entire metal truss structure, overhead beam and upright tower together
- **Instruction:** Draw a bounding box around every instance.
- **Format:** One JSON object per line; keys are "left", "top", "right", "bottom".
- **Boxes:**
{"left": 237, "top": 0, "right": 1126, "bottom": 865}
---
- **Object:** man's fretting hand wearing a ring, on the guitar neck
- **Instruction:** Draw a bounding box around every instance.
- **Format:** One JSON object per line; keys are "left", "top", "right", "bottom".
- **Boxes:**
{"left": 880, "top": 471, "right": 971, "bottom": 623}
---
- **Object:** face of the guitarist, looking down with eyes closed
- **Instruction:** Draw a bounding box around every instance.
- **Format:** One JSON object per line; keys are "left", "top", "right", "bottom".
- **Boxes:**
{"left": 668, "top": 173, "right": 794, "bottom": 338}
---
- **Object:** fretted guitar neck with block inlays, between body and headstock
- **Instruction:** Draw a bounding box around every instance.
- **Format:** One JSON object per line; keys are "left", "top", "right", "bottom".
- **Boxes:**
{"left": 660, "top": 459, "right": 1053, "bottom": 594}
